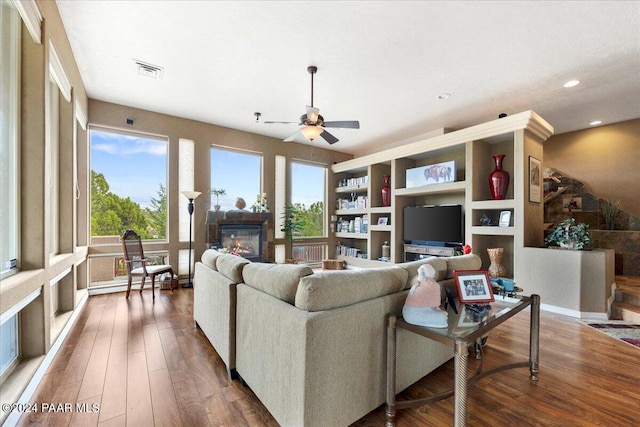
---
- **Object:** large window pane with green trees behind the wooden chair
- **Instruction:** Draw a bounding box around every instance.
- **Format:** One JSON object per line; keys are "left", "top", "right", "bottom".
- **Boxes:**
{"left": 90, "top": 128, "right": 167, "bottom": 244}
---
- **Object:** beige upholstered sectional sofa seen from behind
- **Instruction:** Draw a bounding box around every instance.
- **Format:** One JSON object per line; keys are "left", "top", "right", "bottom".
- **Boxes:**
{"left": 194, "top": 250, "right": 481, "bottom": 426}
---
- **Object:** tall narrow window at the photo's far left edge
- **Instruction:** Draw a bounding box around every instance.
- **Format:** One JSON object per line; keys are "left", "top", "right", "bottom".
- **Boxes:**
{"left": 0, "top": 1, "right": 20, "bottom": 280}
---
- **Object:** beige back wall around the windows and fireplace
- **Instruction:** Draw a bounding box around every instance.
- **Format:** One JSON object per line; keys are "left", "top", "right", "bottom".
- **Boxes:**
{"left": 89, "top": 99, "right": 353, "bottom": 265}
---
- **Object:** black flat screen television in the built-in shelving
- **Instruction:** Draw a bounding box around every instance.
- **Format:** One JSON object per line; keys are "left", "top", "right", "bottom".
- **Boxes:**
{"left": 403, "top": 205, "right": 464, "bottom": 246}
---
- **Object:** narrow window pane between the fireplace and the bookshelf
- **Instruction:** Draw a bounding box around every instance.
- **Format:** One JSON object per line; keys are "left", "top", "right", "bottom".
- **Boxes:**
{"left": 291, "top": 162, "right": 327, "bottom": 237}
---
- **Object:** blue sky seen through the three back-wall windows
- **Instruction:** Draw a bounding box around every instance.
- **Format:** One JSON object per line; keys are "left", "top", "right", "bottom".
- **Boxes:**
{"left": 91, "top": 129, "right": 324, "bottom": 210}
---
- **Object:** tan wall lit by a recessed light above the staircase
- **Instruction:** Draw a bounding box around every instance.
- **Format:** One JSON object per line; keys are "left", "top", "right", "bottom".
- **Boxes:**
{"left": 544, "top": 119, "right": 640, "bottom": 216}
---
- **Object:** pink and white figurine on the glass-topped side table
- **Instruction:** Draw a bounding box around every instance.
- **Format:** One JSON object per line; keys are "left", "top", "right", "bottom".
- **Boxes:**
{"left": 402, "top": 264, "right": 448, "bottom": 328}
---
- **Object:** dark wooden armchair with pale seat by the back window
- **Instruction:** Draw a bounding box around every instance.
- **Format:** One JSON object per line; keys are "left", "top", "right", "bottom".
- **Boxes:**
{"left": 122, "top": 229, "right": 173, "bottom": 300}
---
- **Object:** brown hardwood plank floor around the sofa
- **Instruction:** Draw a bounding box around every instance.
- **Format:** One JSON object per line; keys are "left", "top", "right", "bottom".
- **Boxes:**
{"left": 19, "top": 288, "right": 640, "bottom": 426}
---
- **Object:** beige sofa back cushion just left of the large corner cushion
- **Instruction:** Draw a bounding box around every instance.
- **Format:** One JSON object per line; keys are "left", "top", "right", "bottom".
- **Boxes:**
{"left": 242, "top": 262, "right": 313, "bottom": 304}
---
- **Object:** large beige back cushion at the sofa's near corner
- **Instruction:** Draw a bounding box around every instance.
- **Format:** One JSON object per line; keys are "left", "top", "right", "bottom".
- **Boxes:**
{"left": 295, "top": 267, "right": 407, "bottom": 311}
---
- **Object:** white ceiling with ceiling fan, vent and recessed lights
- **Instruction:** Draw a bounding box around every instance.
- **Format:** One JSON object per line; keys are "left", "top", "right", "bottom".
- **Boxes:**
{"left": 57, "top": 0, "right": 640, "bottom": 154}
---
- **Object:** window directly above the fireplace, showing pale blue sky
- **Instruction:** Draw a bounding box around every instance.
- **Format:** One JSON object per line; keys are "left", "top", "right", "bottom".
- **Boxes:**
{"left": 211, "top": 147, "right": 262, "bottom": 211}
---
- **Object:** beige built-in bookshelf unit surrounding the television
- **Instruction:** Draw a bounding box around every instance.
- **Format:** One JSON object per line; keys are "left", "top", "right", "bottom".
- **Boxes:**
{"left": 332, "top": 111, "right": 553, "bottom": 277}
